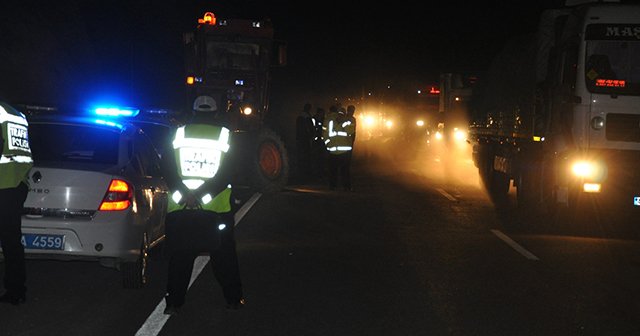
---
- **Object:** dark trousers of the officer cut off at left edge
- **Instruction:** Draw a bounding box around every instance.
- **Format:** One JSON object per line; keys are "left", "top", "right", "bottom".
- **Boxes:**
{"left": 0, "top": 183, "right": 28, "bottom": 296}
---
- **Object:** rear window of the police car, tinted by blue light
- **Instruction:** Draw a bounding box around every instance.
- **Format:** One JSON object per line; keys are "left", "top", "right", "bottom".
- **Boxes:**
{"left": 29, "top": 123, "right": 120, "bottom": 165}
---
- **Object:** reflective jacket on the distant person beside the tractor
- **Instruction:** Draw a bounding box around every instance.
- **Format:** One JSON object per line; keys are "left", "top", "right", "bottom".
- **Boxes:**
{"left": 323, "top": 112, "right": 356, "bottom": 154}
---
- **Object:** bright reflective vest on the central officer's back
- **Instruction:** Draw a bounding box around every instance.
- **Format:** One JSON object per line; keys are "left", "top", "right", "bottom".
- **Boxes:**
{"left": 167, "top": 124, "right": 231, "bottom": 213}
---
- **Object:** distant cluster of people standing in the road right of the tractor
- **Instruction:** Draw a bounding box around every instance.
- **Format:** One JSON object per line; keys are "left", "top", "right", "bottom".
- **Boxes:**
{"left": 296, "top": 103, "right": 357, "bottom": 191}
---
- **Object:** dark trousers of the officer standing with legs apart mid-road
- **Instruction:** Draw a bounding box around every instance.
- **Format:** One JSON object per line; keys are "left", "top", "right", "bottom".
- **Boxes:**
{"left": 167, "top": 214, "right": 243, "bottom": 307}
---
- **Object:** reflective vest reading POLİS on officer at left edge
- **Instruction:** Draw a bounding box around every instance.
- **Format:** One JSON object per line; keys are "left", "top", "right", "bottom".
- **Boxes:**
{"left": 0, "top": 104, "right": 33, "bottom": 189}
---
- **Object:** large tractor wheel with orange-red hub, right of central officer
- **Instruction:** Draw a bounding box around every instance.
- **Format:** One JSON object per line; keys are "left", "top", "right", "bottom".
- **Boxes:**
{"left": 249, "top": 128, "right": 289, "bottom": 193}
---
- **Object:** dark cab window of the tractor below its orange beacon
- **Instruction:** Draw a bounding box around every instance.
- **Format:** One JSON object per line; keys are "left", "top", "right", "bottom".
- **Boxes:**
{"left": 206, "top": 40, "right": 260, "bottom": 70}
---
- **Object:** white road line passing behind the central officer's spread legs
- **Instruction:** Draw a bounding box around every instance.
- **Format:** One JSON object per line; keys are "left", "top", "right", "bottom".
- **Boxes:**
{"left": 136, "top": 193, "right": 262, "bottom": 336}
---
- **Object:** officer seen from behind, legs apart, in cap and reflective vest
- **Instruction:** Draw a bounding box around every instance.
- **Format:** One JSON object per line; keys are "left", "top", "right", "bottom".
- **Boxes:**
{"left": 163, "top": 96, "right": 244, "bottom": 315}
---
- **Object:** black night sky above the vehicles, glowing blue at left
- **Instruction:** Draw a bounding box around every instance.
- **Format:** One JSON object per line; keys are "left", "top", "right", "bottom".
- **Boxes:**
{"left": 0, "top": 0, "right": 562, "bottom": 111}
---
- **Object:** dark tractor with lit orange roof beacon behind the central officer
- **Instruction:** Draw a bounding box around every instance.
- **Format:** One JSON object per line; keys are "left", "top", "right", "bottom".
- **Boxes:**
{"left": 183, "top": 12, "right": 289, "bottom": 193}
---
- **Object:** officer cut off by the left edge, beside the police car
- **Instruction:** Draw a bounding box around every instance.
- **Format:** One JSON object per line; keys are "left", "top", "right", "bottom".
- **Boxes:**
{"left": 0, "top": 102, "right": 33, "bottom": 305}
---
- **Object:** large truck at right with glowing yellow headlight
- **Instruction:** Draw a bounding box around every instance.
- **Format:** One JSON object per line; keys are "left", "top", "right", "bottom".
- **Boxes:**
{"left": 469, "top": 1, "right": 640, "bottom": 223}
